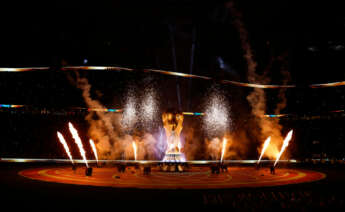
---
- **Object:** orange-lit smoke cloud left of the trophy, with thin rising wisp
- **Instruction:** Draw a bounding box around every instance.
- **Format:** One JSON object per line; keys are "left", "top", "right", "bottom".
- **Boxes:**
{"left": 76, "top": 73, "right": 162, "bottom": 160}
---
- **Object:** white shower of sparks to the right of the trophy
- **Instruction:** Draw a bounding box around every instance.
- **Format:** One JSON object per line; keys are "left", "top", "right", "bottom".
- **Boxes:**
{"left": 203, "top": 93, "right": 230, "bottom": 136}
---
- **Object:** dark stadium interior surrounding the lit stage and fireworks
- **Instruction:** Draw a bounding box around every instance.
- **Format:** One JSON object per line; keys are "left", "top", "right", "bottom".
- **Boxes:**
{"left": 0, "top": 0, "right": 345, "bottom": 211}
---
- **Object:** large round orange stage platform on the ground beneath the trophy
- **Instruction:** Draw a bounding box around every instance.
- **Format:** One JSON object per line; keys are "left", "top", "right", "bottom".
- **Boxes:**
{"left": 19, "top": 167, "right": 326, "bottom": 189}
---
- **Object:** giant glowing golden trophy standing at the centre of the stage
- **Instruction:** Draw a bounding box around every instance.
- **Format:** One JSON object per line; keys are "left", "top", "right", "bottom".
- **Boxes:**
{"left": 162, "top": 110, "right": 185, "bottom": 162}
